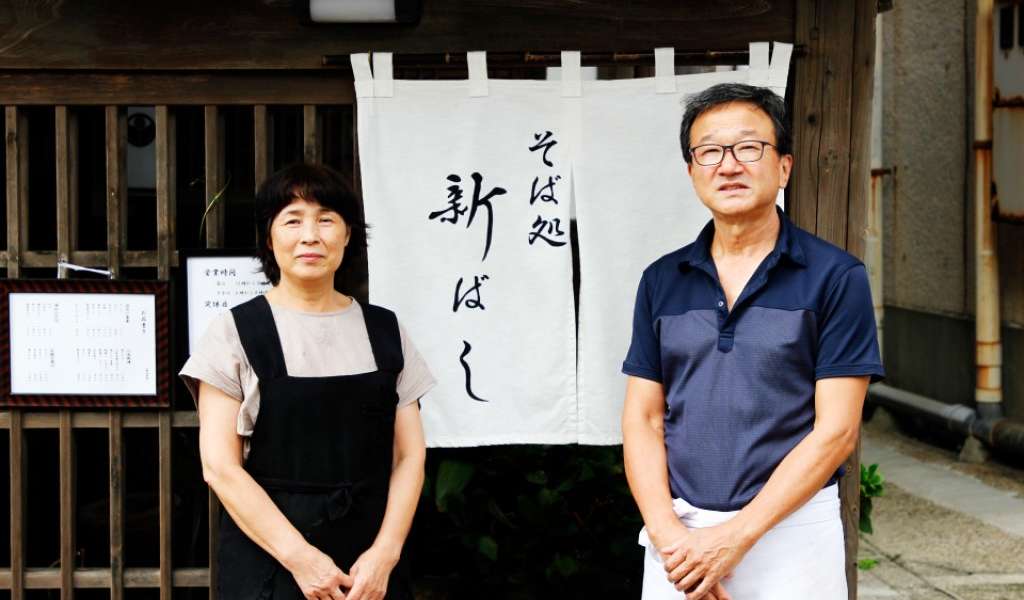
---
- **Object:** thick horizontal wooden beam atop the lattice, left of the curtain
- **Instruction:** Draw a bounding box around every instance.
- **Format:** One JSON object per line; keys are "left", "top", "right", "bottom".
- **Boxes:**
{"left": 0, "top": 71, "right": 355, "bottom": 105}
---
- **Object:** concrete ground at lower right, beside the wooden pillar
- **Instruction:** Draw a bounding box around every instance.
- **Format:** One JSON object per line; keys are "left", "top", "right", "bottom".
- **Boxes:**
{"left": 858, "top": 411, "right": 1024, "bottom": 600}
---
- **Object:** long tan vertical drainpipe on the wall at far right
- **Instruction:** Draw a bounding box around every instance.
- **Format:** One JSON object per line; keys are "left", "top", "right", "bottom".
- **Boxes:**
{"left": 974, "top": 0, "right": 1002, "bottom": 419}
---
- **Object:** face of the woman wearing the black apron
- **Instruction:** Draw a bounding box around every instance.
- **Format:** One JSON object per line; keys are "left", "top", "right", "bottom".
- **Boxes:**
{"left": 269, "top": 198, "right": 349, "bottom": 283}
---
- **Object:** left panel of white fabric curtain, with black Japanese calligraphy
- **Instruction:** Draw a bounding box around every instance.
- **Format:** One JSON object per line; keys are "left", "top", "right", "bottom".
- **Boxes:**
{"left": 358, "top": 55, "right": 577, "bottom": 446}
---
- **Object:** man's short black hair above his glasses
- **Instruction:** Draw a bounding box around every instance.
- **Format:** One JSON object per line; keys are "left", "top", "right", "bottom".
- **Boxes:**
{"left": 679, "top": 83, "right": 793, "bottom": 163}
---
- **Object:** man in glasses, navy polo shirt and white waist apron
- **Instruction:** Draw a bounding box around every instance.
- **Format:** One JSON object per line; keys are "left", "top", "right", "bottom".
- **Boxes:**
{"left": 623, "top": 84, "right": 884, "bottom": 600}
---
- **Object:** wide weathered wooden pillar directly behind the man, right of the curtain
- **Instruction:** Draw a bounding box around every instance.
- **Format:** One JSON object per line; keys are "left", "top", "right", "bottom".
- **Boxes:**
{"left": 790, "top": 0, "right": 877, "bottom": 600}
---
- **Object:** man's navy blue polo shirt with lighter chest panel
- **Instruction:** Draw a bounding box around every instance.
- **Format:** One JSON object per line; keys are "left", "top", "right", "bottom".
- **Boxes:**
{"left": 623, "top": 211, "right": 885, "bottom": 511}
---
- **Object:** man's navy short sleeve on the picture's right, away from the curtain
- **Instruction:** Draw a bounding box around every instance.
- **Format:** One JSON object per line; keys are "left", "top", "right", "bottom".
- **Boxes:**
{"left": 814, "top": 263, "right": 885, "bottom": 383}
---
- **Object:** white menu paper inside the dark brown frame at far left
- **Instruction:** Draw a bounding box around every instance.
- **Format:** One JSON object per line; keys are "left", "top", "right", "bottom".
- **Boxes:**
{"left": 9, "top": 293, "right": 157, "bottom": 395}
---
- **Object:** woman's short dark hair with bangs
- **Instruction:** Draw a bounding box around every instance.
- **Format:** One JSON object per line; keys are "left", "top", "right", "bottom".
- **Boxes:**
{"left": 256, "top": 163, "right": 367, "bottom": 288}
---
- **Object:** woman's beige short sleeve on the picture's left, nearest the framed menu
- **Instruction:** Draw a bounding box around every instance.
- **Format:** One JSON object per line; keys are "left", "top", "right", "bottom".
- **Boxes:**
{"left": 178, "top": 311, "right": 249, "bottom": 403}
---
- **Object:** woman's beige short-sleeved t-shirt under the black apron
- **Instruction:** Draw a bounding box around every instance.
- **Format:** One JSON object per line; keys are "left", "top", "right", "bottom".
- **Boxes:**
{"left": 179, "top": 299, "right": 436, "bottom": 438}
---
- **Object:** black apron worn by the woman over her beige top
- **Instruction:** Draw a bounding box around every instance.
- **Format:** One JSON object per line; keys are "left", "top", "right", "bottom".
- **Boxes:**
{"left": 217, "top": 296, "right": 413, "bottom": 600}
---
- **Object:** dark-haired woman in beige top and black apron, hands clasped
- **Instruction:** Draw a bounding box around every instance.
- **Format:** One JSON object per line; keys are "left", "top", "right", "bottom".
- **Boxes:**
{"left": 181, "top": 165, "right": 434, "bottom": 600}
